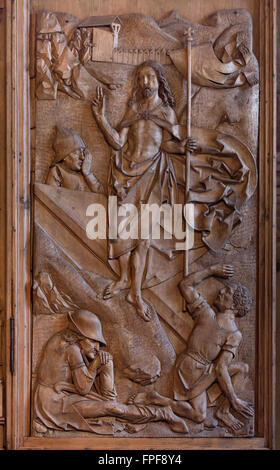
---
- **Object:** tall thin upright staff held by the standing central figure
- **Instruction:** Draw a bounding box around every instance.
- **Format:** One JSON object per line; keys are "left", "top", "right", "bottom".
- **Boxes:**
{"left": 183, "top": 27, "right": 193, "bottom": 312}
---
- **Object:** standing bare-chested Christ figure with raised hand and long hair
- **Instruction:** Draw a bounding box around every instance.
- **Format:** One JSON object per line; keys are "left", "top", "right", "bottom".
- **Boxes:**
{"left": 92, "top": 61, "right": 196, "bottom": 321}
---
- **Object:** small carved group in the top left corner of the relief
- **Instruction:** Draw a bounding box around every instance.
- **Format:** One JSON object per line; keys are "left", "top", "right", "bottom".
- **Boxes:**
{"left": 36, "top": 11, "right": 119, "bottom": 100}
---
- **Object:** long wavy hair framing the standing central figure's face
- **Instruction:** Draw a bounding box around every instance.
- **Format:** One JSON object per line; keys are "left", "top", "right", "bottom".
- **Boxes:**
{"left": 128, "top": 60, "right": 175, "bottom": 108}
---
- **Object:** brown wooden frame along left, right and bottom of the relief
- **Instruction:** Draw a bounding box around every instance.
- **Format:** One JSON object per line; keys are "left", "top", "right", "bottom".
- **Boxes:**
{"left": 2, "top": 0, "right": 276, "bottom": 450}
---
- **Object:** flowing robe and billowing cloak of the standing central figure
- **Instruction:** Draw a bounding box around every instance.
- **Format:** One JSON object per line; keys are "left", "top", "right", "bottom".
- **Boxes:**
{"left": 108, "top": 108, "right": 257, "bottom": 259}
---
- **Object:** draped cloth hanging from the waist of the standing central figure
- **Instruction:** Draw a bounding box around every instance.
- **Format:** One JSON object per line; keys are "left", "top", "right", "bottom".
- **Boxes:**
{"left": 109, "top": 150, "right": 177, "bottom": 259}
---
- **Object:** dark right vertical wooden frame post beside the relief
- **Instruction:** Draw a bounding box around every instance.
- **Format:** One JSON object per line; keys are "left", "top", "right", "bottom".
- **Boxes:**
{"left": 255, "top": 0, "right": 277, "bottom": 449}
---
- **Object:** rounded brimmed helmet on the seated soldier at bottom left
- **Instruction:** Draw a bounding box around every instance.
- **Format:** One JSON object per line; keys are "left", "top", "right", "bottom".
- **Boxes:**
{"left": 68, "top": 310, "right": 107, "bottom": 346}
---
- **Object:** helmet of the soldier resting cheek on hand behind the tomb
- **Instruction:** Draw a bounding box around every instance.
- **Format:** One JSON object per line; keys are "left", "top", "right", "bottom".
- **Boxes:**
{"left": 52, "top": 126, "right": 86, "bottom": 166}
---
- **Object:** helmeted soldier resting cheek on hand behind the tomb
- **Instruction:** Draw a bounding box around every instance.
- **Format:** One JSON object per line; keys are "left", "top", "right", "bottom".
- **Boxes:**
{"left": 46, "top": 127, "right": 104, "bottom": 193}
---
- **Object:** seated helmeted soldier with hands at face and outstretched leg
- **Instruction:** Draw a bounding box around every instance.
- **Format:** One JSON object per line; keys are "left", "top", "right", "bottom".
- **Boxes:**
{"left": 34, "top": 310, "right": 188, "bottom": 434}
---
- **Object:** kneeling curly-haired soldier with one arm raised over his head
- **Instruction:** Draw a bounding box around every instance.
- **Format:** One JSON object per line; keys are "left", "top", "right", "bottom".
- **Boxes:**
{"left": 130, "top": 265, "right": 253, "bottom": 431}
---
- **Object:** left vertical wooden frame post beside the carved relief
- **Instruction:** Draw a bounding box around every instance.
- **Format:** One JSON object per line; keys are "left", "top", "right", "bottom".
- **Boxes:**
{"left": 5, "top": 0, "right": 31, "bottom": 449}
